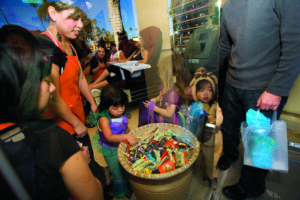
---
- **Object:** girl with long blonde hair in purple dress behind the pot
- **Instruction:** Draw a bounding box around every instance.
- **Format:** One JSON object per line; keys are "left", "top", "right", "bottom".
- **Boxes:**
{"left": 139, "top": 57, "right": 181, "bottom": 126}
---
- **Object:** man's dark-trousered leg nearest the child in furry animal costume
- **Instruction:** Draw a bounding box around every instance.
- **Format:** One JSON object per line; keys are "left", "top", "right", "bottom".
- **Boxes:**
{"left": 218, "top": 83, "right": 243, "bottom": 170}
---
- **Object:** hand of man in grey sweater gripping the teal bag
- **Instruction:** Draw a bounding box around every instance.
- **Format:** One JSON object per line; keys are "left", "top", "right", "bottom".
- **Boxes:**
{"left": 256, "top": 91, "right": 281, "bottom": 110}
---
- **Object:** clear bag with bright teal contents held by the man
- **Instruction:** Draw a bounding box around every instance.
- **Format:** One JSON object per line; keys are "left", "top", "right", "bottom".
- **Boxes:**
{"left": 241, "top": 109, "right": 288, "bottom": 172}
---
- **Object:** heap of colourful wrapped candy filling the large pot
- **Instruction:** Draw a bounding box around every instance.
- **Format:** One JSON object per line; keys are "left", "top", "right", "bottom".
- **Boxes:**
{"left": 123, "top": 128, "right": 193, "bottom": 174}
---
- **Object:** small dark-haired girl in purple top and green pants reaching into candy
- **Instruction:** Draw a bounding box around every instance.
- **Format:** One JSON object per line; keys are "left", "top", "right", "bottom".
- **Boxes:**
{"left": 98, "top": 85, "right": 136, "bottom": 197}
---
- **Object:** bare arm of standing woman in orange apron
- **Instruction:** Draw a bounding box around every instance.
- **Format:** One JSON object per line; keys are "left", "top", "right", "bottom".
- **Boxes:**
{"left": 50, "top": 64, "right": 87, "bottom": 137}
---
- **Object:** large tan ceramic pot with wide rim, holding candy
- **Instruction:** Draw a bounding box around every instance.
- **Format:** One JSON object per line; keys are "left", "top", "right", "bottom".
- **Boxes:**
{"left": 118, "top": 123, "right": 200, "bottom": 200}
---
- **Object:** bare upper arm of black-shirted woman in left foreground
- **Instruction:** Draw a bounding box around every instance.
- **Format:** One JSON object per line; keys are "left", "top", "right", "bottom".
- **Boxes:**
{"left": 59, "top": 151, "right": 103, "bottom": 200}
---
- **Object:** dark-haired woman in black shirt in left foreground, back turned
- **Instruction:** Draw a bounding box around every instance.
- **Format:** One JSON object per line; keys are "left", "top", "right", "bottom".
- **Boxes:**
{"left": 0, "top": 25, "right": 103, "bottom": 199}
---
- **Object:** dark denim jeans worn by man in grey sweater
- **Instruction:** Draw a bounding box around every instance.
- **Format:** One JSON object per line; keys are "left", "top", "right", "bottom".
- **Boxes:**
{"left": 221, "top": 82, "right": 287, "bottom": 195}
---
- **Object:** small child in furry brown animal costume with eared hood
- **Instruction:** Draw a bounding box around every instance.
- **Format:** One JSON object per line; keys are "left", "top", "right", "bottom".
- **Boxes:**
{"left": 190, "top": 70, "right": 223, "bottom": 189}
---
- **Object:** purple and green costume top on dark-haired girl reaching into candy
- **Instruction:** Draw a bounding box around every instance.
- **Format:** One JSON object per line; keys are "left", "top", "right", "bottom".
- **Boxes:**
{"left": 98, "top": 110, "right": 128, "bottom": 150}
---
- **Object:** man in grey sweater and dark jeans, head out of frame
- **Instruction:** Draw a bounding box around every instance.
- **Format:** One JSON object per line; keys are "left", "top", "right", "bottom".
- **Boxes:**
{"left": 218, "top": 0, "right": 300, "bottom": 199}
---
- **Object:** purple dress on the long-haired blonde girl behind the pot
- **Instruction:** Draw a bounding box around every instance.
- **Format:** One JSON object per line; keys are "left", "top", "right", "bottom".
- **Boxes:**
{"left": 139, "top": 85, "right": 181, "bottom": 127}
